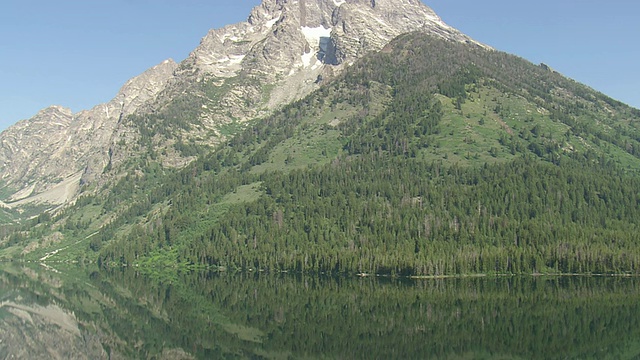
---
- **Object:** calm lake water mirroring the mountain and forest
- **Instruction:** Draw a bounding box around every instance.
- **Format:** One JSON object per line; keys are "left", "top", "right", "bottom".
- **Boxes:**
{"left": 0, "top": 263, "right": 640, "bottom": 359}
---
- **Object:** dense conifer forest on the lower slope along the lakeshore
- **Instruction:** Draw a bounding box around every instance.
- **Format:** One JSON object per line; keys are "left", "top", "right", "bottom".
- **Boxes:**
{"left": 152, "top": 157, "right": 640, "bottom": 275}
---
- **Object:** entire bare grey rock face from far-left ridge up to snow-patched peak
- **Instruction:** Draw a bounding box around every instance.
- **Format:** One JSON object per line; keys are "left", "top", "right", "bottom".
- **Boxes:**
{"left": 0, "top": 0, "right": 482, "bottom": 211}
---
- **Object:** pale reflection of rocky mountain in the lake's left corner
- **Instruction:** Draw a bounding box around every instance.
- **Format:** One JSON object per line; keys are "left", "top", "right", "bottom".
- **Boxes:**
{"left": 0, "top": 264, "right": 191, "bottom": 359}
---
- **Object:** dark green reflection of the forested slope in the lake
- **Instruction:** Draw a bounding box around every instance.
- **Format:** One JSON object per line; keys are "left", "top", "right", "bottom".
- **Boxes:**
{"left": 102, "top": 273, "right": 640, "bottom": 359}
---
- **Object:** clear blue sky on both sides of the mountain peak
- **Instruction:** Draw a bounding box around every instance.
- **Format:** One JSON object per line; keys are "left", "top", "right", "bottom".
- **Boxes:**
{"left": 0, "top": 0, "right": 640, "bottom": 130}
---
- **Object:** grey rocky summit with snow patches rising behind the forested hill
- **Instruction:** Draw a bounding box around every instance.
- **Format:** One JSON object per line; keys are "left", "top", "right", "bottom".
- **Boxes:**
{"left": 179, "top": 0, "right": 480, "bottom": 123}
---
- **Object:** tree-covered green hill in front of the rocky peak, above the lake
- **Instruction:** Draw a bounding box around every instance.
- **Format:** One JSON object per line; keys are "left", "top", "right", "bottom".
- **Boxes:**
{"left": 92, "top": 35, "right": 640, "bottom": 275}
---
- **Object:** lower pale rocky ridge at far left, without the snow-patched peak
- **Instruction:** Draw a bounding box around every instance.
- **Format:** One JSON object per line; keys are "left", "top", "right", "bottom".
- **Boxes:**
{"left": 0, "top": 60, "right": 177, "bottom": 207}
